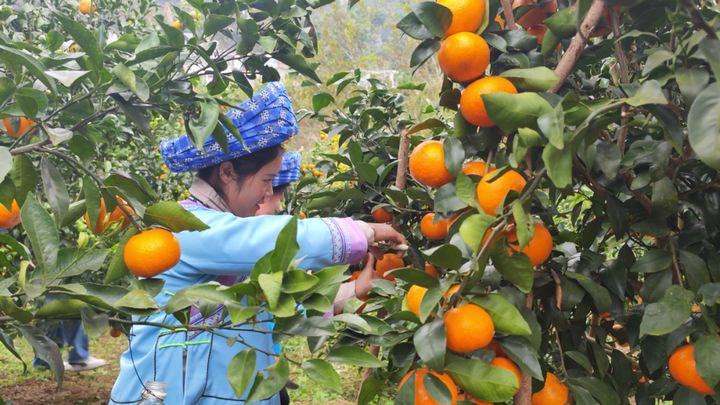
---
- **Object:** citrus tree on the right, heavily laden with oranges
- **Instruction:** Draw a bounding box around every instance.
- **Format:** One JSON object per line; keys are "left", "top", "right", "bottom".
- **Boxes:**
{"left": 298, "top": 0, "right": 720, "bottom": 404}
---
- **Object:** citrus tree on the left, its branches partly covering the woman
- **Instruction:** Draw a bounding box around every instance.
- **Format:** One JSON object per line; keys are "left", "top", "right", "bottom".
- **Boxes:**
{"left": 0, "top": 0, "right": 372, "bottom": 400}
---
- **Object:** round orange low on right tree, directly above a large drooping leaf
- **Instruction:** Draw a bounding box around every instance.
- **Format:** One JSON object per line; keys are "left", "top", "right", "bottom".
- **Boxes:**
{"left": 443, "top": 304, "right": 495, "bottom": 353}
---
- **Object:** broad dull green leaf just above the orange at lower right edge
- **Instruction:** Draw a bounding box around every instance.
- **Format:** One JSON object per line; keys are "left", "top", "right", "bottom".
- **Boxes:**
{"left": 640, "top": 285, "right": 694, "bottom": 337}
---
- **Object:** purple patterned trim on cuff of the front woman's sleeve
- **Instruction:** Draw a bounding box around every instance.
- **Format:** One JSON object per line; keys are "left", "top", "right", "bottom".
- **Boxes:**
{"left": 323, "top": 218, "right": 368, "bottom": 264}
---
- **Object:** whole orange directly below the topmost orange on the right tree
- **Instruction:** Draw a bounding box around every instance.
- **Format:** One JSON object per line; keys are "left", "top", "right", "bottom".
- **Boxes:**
{"left": 437, "top": 32, "right": 490, "bottom": 82}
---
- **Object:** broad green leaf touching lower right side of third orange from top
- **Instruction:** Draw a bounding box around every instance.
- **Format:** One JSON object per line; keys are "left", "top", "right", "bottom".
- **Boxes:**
{"left": 482, "top": 93, "right": 553, "bottom": 133}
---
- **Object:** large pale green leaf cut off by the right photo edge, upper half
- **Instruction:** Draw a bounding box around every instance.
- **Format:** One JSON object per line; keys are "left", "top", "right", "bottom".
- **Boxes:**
{"left": 687, "top": 83, "right": 720, "bottom": 170}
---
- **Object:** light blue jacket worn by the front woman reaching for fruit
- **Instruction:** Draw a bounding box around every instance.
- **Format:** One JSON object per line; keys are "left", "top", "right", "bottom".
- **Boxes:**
{"left": 110, "top": 208, "right": 367, "bottom": 405}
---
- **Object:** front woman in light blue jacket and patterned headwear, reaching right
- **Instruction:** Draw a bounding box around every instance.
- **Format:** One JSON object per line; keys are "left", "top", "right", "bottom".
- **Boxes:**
{"left": 110, "top": 83, "right": 405, "bottom": 405}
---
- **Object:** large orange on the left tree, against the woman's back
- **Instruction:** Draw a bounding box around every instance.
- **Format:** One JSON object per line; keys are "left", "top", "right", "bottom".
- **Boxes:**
{"left": 123, "top": 228, "right": 180, "bottom": 277}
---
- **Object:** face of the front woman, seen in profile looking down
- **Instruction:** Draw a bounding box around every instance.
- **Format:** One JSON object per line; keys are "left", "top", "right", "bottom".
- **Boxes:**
{"left": 220, "top": 154, "right": 282, "bottom": 217}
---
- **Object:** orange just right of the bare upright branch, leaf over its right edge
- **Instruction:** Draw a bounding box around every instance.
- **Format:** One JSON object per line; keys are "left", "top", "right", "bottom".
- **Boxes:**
{"left": 408, "top": 139, "right": 453, "bottom": 188}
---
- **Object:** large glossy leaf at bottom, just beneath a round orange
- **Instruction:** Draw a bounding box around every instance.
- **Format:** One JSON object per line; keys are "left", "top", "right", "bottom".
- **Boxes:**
{"left": 445, "top": 355, "right": 518, "bottom": 402}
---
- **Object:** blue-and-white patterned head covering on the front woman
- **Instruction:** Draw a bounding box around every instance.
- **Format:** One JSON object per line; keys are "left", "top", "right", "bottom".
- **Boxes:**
{"left": 160, "top": 82, "right": 298, "bottom": 173}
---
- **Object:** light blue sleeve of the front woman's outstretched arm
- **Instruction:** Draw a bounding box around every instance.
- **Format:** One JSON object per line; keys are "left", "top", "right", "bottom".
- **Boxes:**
{"left": 175, "top": 209, "right": 349, "bottom": 275}
